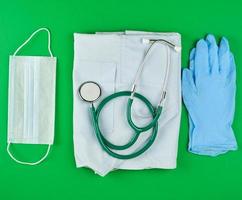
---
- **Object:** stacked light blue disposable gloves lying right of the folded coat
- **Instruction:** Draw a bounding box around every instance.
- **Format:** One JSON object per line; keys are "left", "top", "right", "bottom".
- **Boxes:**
{"left": 182, "top": 35, "right": 237, "bottom": 156}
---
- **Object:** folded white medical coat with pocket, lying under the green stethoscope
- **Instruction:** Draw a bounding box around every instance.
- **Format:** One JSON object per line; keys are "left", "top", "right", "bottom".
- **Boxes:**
{"left": 73, "top": 31, "right": 181, "bottom": 176}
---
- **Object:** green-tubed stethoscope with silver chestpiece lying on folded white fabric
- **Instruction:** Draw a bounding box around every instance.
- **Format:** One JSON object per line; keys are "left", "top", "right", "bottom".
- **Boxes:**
{"left": 78, "top": 39, "right": 180, "bottom": 159}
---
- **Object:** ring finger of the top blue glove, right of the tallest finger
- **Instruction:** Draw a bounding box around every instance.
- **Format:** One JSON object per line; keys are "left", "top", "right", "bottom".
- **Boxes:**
{"left": 218, "top": 37, "right": 230, "bottom": 77}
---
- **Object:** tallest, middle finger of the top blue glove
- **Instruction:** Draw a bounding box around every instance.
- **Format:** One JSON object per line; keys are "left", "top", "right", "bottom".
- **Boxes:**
{"left": 206, "top": 34, "right": 219, "bottom": 74}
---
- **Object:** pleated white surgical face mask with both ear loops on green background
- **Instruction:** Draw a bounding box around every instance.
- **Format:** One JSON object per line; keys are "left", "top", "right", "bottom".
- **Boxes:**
{"left": 7, "top": 28, "right": 56, "bottom": 165}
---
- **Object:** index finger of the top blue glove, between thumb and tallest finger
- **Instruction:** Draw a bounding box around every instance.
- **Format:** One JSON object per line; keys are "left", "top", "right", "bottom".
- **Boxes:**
{"left": 194, "top": 39, "right": 210, "bottom": 85}
